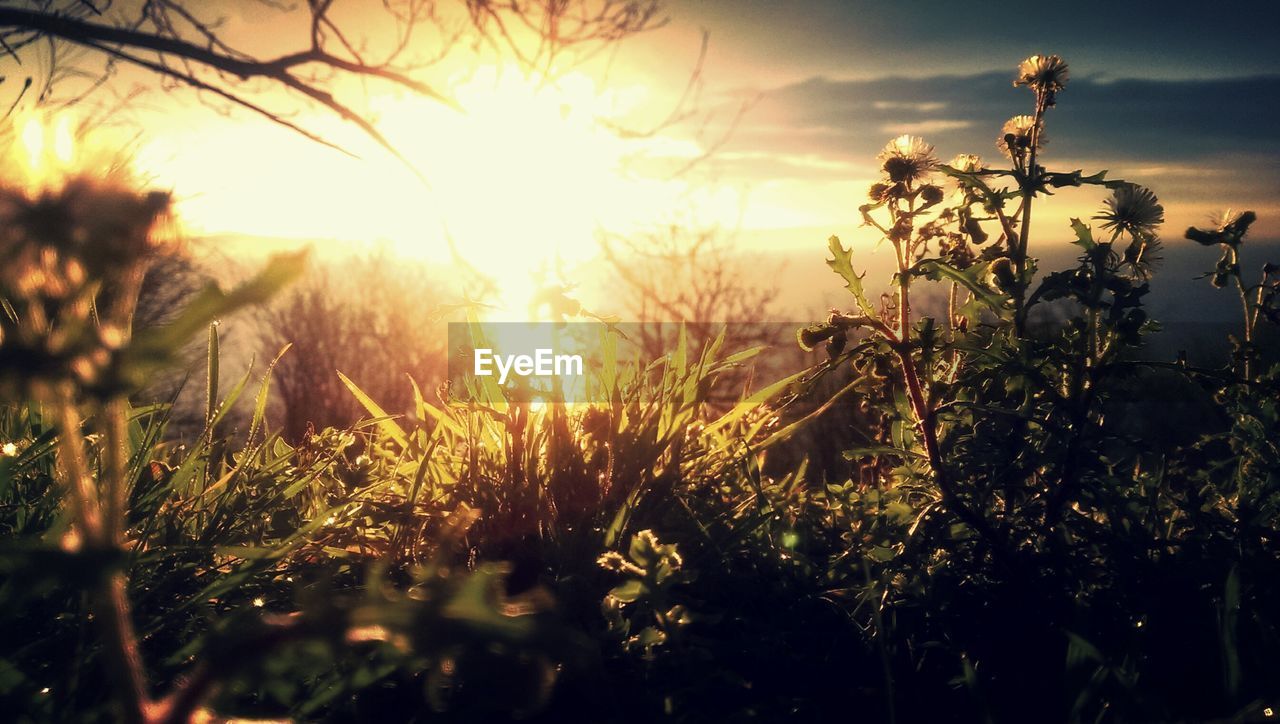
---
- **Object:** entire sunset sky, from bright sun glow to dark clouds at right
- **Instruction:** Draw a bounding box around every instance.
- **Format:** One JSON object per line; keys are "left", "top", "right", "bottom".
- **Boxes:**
{"left": 0, "top": 0, "right": 1280, "bottom": 317}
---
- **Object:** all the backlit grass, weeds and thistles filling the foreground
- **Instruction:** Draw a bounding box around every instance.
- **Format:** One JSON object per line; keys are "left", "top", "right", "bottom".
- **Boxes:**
{"left": 0, "top": 56, "right": 1280, "bottom": 721}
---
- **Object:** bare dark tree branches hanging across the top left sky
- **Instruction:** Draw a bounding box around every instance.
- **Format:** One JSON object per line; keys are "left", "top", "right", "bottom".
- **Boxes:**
{"left": 0, "top": 0, "right": 663, "bottom": 160}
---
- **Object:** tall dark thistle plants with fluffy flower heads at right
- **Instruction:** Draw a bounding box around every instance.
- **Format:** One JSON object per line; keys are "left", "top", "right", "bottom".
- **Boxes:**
{"left": 773, "top": 56, "right": 1280, "bottom": 721}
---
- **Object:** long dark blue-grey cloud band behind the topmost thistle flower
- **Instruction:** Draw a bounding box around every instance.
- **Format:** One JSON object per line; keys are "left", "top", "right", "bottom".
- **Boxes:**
{"left": 742, "top": 73, "right": 1280, "bottom": 161}
